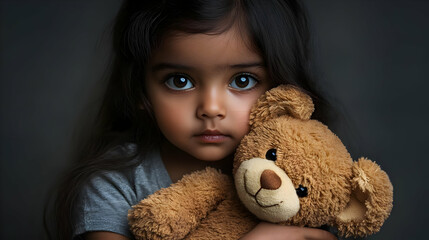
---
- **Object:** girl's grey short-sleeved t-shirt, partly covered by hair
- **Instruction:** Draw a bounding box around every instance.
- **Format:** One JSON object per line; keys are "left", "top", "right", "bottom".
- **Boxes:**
{"left": 74, "top": 145, "right": 171, "bottom": 239}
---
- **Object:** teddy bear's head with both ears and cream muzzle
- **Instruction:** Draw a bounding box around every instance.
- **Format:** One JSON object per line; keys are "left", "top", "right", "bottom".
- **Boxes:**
{"left": 234, "top": 85, "right": 393, "bottom": 236}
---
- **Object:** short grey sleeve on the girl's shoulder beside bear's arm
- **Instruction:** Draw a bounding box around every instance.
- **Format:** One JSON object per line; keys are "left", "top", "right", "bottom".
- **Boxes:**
{"left": 73, "top": 173, "right": 136, "bottom": 239}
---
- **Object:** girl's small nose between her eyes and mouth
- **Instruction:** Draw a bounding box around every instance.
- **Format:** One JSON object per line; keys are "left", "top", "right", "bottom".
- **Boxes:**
{"left": 197, "top": 89, "right": 226, "bottom": 119}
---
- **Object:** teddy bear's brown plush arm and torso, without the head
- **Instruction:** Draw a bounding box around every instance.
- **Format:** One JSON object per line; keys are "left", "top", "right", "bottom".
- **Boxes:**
{"left": 128, "top": 168, "right": 257, "bottom": 240}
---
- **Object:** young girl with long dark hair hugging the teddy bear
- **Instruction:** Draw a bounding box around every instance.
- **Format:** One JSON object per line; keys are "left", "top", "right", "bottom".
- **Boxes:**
{"left": 51, "top": 0, "right": 335, "bottom": 240}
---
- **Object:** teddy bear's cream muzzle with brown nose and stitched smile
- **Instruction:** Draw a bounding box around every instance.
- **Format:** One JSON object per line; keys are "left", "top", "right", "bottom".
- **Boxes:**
{"left": 234, "top": 158, "right": 300, "bottom": 223}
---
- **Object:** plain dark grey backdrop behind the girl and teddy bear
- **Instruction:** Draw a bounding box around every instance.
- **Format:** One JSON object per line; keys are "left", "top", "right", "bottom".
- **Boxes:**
{"left": 0, "top": 0, "right": 429, "bottom": 239}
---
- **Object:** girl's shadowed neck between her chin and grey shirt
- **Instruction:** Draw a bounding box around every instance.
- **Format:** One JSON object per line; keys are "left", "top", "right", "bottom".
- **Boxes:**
{"left": 161, "top": 140, "right": 233, "bottom": 183}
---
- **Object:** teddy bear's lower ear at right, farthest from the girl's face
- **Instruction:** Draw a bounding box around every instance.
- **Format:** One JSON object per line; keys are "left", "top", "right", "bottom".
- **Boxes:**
{"left": 336, "top": 158, "right": 393, "bottom": 237}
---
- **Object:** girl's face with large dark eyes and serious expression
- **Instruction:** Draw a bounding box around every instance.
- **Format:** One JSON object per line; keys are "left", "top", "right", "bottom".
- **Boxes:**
{"left": 146, "top": 29, "right": 270, "bottom": 161}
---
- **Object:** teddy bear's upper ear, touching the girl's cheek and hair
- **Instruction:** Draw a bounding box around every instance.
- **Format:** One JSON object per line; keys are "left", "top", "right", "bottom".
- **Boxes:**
{"left": 250, "top": 85, "right": 314, "bottom": 126}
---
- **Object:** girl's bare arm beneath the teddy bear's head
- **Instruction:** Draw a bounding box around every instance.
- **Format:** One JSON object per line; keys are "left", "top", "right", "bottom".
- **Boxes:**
{"left": 241, "top": 222, "right": 337, "bottom": 240}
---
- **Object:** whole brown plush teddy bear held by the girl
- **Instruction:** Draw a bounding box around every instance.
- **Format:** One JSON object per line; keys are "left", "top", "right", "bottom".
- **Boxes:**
{"left": 128, "top": 85, "right": 393, "bottom": 239}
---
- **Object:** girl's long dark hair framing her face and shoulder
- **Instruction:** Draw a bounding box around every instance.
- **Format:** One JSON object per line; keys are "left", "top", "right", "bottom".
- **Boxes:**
{"left": 45, "top": 0, "right": 332, "bottom": 239}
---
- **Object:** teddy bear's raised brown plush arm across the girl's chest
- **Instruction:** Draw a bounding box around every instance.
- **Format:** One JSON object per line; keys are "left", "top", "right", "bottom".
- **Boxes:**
{"left": 128, "top": 168, "right": 233, "bottom": 239}
